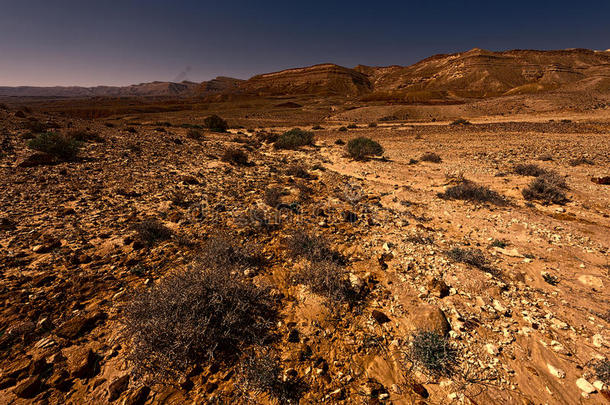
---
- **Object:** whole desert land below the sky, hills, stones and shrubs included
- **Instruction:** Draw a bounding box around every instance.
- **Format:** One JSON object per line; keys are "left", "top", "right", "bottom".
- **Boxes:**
{"left": 0, "top": 48, "right": 610, "bottom": 405}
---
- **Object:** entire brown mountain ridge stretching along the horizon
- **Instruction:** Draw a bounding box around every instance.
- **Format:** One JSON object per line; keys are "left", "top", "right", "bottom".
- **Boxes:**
{"left": 0, "top": 48, "right": 610, "bottom": 102}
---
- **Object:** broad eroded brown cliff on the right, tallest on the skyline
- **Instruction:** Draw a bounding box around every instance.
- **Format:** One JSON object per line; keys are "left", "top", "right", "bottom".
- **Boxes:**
{"left": 355, "top": 49, "right": 610, "bottom": 98}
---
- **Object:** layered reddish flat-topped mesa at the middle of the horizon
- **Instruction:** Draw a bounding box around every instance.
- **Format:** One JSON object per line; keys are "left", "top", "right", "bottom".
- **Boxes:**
{"left": 240, "top": 63, "right": 372, "bottom": 96}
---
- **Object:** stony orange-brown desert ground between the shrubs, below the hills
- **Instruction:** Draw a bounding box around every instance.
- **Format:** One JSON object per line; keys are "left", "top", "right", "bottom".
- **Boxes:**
{"left": 0, "top": 105, "right": 610, "bottom": 404}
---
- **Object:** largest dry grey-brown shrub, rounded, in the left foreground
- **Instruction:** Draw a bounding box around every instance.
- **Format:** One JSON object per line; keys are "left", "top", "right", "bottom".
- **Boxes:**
{"left": 123, "top": 268, "right": 276, "bottom": 383}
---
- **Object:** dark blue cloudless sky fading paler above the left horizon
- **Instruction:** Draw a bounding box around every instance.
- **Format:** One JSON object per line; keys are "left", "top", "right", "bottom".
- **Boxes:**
{"left": 0, "top": 0, "right": 610, "bottom": 86}
